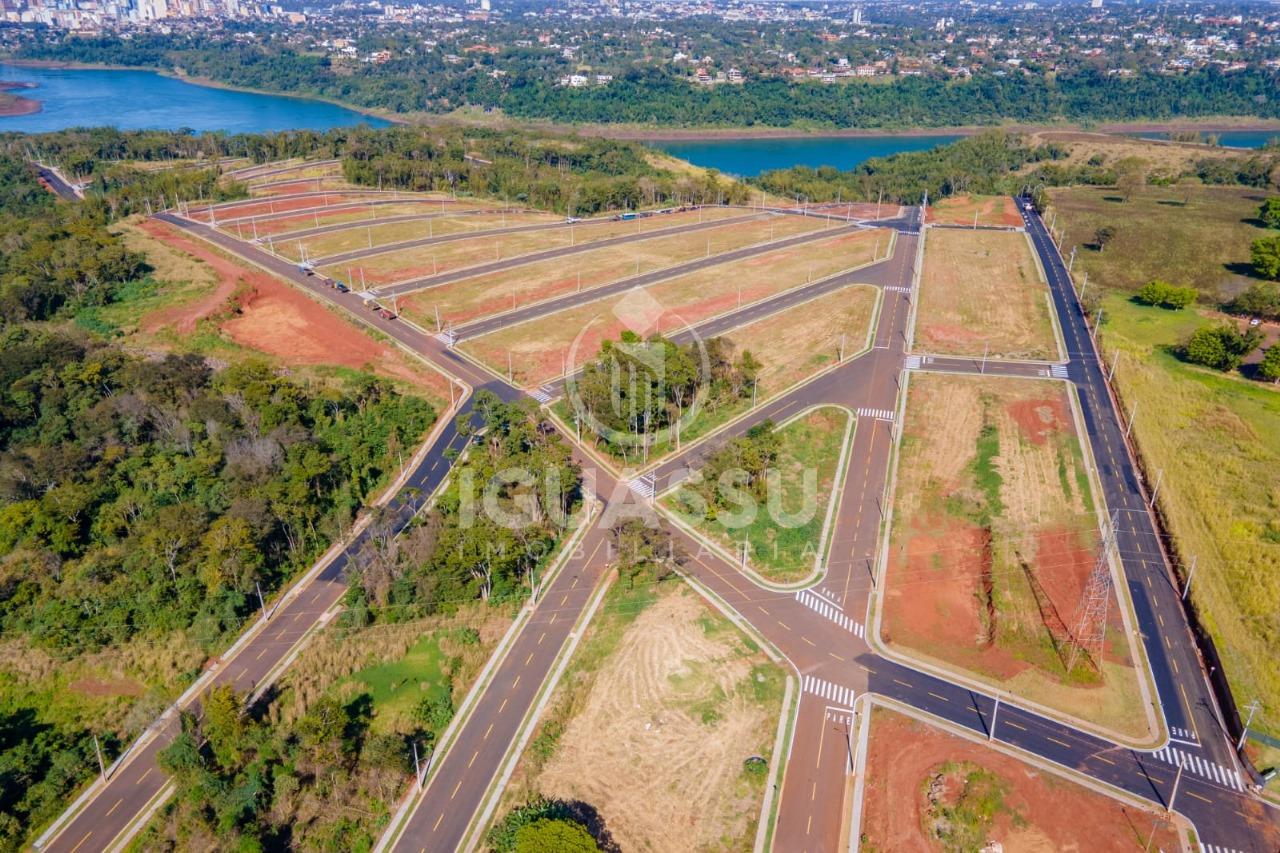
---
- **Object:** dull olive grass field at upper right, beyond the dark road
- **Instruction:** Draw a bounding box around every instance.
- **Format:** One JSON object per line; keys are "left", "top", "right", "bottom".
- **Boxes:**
{"left": 1050, "top": 187, "right": 1268, "bottom": 300}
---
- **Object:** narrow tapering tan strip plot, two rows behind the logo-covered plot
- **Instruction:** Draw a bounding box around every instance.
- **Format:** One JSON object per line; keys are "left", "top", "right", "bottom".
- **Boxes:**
{"left": 324, "top": 207, "right": 745, "bottom": 287}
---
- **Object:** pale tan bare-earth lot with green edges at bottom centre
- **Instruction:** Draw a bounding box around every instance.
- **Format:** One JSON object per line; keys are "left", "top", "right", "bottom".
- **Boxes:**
{"left": 498, "top": 581, "right": 785, "bottom": 850}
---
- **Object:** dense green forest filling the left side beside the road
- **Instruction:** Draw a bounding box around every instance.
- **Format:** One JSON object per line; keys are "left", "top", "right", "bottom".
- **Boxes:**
{"left": 0, "top": 142, "right": 435, "bottom": 849}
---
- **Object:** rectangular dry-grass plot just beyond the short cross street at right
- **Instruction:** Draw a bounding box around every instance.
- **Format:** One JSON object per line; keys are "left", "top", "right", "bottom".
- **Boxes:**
{"left": 915, "top": 228, "right": 1061, "bottom": 360}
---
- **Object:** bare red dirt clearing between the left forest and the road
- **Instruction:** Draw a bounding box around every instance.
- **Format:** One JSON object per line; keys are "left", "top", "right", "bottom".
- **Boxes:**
{"left": 223, "top": 278, "right": 449, "bottom": 397}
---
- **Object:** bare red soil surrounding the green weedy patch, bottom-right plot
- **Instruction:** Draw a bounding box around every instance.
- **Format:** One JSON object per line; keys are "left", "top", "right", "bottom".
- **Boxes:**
{"left": 861, "top": 708, "right": 1181, "bottom": 853}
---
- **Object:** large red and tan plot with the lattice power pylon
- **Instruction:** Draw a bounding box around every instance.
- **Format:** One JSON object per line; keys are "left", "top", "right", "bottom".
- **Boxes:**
{"left": 882, "top": 374, "right": 1149, "bottom": 738}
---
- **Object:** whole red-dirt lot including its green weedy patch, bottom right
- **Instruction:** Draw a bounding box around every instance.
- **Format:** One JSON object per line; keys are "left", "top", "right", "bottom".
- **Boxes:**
{"left": 860, "top": 708, "right": 1181, "bottom": 853}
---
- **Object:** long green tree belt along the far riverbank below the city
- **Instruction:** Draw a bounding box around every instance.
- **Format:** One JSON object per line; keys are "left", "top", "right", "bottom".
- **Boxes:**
{"left": 22, "top": 35, "right": 1280, "bottom": 128}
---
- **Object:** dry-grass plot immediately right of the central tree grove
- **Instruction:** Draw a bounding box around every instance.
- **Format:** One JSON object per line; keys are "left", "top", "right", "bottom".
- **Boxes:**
{"left": 724, "top": 284, "right": 877, "bottom": 400}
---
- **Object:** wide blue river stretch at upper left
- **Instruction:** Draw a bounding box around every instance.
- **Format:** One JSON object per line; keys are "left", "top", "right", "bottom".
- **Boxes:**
{"left": 0, "top": 65, "right": 389, "bottom": 133}
